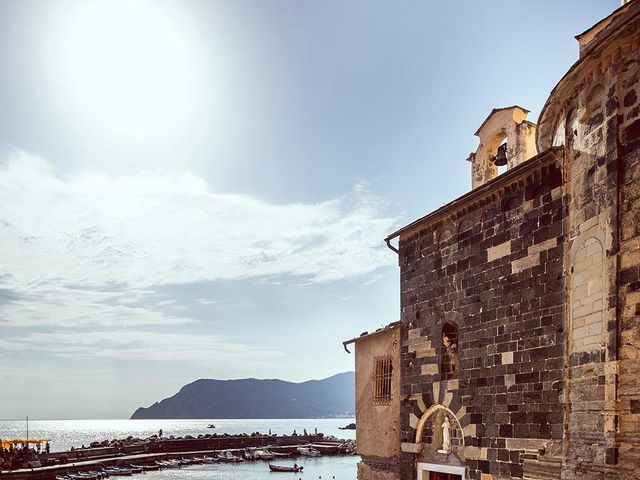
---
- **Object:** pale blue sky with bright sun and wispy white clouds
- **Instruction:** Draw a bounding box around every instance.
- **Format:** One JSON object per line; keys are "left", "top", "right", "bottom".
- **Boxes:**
{"left": 0, "top": 0, "right": 619, "bottom": 419}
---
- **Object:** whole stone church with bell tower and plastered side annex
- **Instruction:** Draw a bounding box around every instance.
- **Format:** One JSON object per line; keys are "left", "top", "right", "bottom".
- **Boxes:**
{"left": 345, "top": 0, "right": 640, "bottom": 480}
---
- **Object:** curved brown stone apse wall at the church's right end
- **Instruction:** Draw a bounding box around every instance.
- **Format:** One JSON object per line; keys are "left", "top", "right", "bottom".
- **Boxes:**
{"left": 554, "top": 13, "right": 640, "bottom": 480}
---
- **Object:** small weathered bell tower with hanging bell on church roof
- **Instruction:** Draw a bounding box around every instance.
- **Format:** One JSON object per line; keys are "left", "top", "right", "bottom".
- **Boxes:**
{"left": 467, "top": 105, "right": 536, "bottom": 189}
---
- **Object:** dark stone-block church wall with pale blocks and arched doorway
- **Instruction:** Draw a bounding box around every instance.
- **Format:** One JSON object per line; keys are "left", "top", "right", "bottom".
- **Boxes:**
{"left": 399, "top": 150, "right": 565, "bottom": 479}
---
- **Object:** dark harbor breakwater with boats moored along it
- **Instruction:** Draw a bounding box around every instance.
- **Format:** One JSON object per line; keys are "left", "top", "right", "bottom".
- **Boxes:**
{"left": 1, "top": 432, "right": 355, "bottom": 480}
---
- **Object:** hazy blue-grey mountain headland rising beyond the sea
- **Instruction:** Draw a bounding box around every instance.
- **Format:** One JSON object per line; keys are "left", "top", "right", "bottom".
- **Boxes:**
{"left": 131, "top": 372, "right": 355, "bottom": 419}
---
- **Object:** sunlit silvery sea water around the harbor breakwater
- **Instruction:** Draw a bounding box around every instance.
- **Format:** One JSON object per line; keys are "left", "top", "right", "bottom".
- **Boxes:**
{"left": 0, "top": 418, "right": 360, "bottom": 480}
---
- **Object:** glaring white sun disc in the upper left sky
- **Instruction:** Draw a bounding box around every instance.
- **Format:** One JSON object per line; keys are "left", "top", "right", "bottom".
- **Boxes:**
{"left": 47, "top": 0, "right": 200, "bottom": 142}
